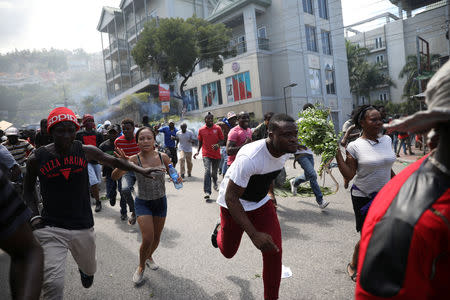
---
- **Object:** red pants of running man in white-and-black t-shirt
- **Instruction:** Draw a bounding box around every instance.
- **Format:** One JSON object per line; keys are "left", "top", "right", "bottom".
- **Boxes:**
{"left": 217, "top": 200, "right": 282, "bottom": 300}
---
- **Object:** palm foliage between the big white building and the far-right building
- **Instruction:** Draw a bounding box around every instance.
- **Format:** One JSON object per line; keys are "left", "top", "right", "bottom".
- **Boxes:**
{"left": 345, "top": 40, "right": 394, "bottom": 103}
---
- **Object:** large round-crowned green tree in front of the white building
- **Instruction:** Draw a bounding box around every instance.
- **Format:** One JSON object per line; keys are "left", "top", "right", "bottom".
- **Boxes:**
{"left": 131, "top": 16, "right": 235, "bottom": 96}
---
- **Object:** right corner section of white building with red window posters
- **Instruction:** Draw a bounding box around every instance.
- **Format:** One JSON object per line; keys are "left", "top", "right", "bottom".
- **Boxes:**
{"left": 181, "top": 0, "right": 351, "bottom": 127}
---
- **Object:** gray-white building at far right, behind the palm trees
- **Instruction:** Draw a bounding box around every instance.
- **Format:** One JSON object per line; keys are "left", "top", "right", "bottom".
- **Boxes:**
{"left": 346, "top": 1, "right": 450, "bottom": 106}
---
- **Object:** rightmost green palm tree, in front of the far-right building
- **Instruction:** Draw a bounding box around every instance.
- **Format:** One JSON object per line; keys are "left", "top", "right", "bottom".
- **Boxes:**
{"left": 398, "top": 54, "right": 440, "bottom": 99}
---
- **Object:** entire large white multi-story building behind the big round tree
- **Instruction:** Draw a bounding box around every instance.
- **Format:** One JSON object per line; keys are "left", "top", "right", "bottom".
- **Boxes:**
{"left": 97, "top": 0, "right": 352, "bottom": 128}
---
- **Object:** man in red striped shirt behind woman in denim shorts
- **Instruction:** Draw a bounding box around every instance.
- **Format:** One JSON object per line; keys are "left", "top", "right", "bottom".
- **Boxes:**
{"left": 114, "top": 119, "right": 139, "bottom": 225}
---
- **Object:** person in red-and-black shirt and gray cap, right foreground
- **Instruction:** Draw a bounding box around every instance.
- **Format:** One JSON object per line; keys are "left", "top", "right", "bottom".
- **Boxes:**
{"left": 355, "top": 62, "right": 450, "bottom": 299}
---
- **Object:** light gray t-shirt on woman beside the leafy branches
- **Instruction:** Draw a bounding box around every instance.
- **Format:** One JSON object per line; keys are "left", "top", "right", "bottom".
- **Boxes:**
{"left": 347, "top": 135, "right": 396, "bottom": 197}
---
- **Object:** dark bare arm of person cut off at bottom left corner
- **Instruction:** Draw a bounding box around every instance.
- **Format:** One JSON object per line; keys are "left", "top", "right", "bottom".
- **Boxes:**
{"left": 0, "top": 222, "right": 44, "bottom": 299}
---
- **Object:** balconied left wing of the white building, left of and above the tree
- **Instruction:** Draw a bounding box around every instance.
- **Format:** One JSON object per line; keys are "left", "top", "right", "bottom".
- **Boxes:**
{"left": 97, "top": 0, "right": 213, "bottom": 104}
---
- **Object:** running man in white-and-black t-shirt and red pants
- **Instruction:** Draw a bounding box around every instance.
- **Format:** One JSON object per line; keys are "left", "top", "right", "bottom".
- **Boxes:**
{"left": 211, "top": 114, "right": 298, "bottom": 300}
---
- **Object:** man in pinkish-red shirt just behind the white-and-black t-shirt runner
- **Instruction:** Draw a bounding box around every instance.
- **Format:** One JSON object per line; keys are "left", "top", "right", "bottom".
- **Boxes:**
{"left": 227, "top": 111, "right": 252, "bottom": 167}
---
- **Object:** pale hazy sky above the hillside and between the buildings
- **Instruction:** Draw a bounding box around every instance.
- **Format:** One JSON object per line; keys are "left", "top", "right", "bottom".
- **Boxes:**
{"left": 0, "top": 0, "right": 397, "bottom": 54}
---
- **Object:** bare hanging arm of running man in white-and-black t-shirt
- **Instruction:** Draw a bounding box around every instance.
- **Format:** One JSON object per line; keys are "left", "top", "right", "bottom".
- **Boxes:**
{"left": 225, "top": 179, "right": 279, "bottom": 252}
